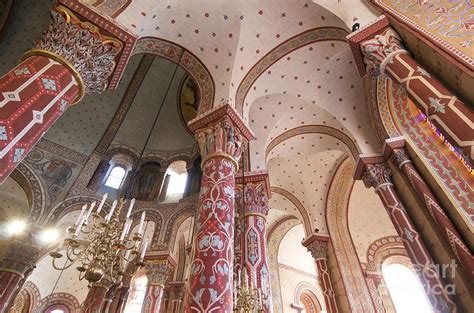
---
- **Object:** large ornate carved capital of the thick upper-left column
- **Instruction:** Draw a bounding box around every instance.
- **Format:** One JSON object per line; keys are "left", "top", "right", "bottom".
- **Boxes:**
{"left": 33, "top": 6, "right": 122, "bottom": 94}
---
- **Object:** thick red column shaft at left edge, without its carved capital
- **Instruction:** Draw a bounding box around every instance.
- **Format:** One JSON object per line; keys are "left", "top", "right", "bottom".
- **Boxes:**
{"left": 0, "top": 56, "right": 79, "bottom": 183}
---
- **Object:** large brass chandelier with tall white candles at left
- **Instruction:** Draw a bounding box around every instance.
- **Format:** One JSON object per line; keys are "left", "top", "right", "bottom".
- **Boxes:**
{"left": 50, "top": 194, "right": 148, "bottom": 284}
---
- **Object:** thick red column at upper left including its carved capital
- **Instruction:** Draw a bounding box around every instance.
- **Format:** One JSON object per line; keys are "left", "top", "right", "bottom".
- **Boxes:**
{"left": 0, "top": 6, "right": 121, "bottom": 183}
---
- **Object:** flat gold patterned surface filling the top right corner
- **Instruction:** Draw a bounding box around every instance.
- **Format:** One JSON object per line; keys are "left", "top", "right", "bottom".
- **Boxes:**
{"left": 372, "top": 0, "right": 474, "bottom": 66}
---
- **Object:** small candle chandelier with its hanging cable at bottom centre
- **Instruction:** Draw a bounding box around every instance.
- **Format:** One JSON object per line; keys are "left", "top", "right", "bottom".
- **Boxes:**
{"left": 233, "top": 157, "right": 269, "bottom": 313}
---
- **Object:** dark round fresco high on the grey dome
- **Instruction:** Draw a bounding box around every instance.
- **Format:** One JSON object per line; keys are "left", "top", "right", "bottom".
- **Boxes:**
{"left": 178, "top": 75, "right": 201, "bottom": 125}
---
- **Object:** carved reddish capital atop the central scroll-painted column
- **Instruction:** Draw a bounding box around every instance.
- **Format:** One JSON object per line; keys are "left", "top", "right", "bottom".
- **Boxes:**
{"left": 196, "top": 116, "right": 247, "bottom": 162}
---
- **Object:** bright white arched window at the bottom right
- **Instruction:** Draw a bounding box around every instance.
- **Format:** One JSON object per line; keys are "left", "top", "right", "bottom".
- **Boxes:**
{"left": 382, "top": 263, "right": 433, "bottom": 313}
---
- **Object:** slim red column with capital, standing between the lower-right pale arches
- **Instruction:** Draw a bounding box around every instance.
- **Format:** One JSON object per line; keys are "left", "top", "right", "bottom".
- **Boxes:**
{"left": 301, "top": 233, "right": 338, "bottom": 313}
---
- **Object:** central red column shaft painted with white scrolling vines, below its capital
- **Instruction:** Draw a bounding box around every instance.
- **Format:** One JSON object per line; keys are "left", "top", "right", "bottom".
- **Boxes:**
{"left": 186, "top": 156, "right": 236, "bottom": 312}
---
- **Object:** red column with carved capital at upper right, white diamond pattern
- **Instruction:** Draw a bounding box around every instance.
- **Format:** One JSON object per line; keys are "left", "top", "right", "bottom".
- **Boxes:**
{"left": 347, "top": 16, "right": 474, "bottom": 160}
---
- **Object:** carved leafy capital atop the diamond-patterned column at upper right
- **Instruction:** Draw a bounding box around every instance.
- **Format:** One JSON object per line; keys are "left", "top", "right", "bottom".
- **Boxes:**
{"left": 360, "top": 28, "right": 405, "bottom": 67}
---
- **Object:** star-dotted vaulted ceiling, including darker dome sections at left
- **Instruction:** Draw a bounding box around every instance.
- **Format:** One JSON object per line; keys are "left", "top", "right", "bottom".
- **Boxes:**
{"left": 0, "top": 0, "right": 396, "bottom": 241}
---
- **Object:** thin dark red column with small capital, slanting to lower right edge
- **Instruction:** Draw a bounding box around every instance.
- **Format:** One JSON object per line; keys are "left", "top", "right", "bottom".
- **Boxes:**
{"left": 386, "top": 139, "right": 474, "bottom": 281}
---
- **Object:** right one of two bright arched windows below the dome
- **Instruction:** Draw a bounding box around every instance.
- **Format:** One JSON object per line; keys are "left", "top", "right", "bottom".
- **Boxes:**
{"left": 162, "top": 161, "right": 188, "bottom": 202}
